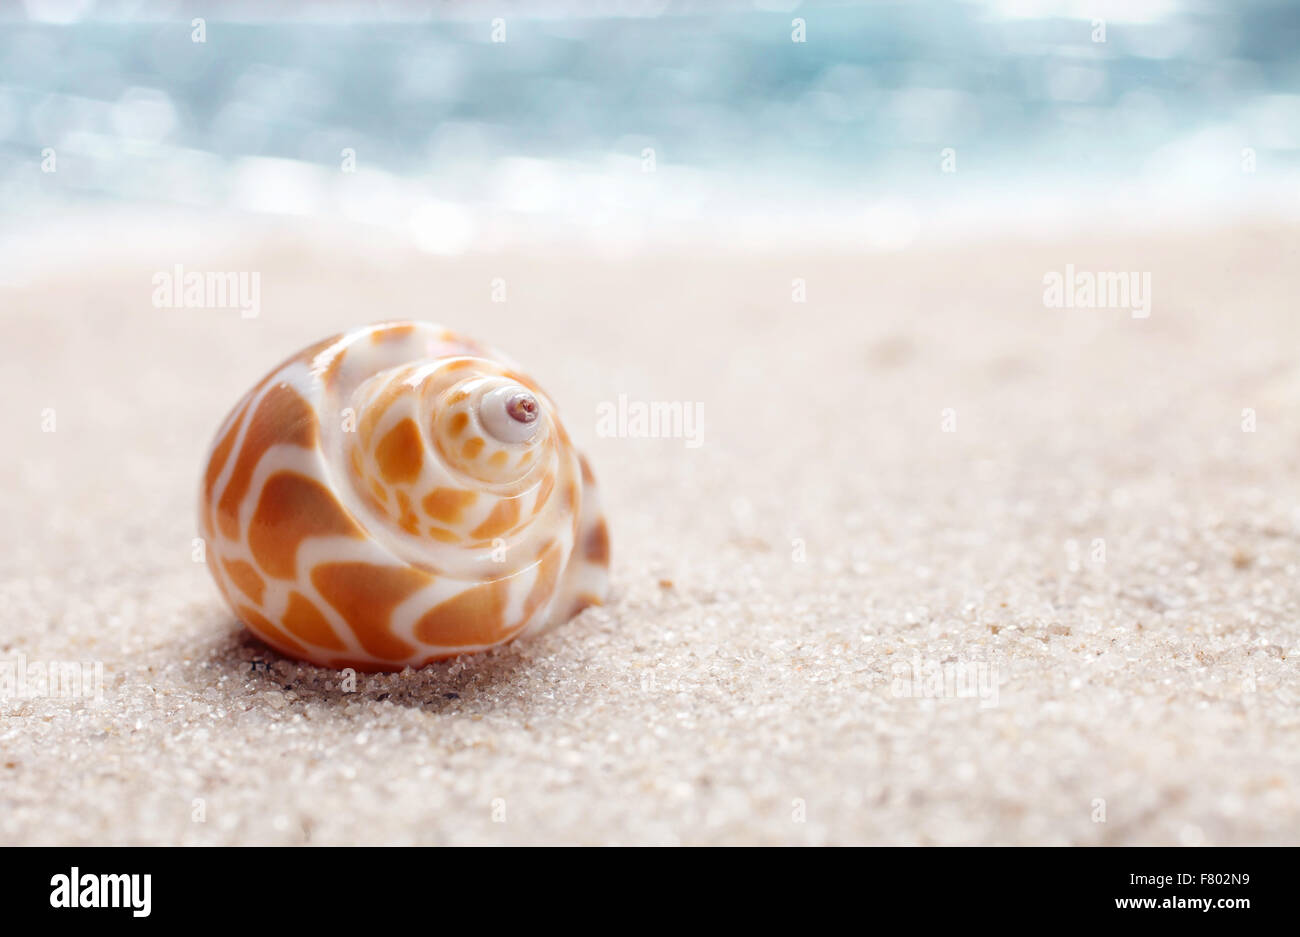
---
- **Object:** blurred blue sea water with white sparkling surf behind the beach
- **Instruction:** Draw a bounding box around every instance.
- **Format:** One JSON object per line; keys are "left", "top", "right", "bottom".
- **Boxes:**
{"left": 0, "top": 0, "right": 1300, "bottom": 269}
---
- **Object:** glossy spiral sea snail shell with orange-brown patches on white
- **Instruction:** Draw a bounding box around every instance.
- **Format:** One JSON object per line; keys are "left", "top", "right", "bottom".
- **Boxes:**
{"left": 199, "top": 322, "right": 610, "bottom": 671}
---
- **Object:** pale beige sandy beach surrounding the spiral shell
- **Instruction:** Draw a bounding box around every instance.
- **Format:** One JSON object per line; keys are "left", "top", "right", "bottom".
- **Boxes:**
{"left": 0, "top": 222, "right": 1300, "bottom": 845}
